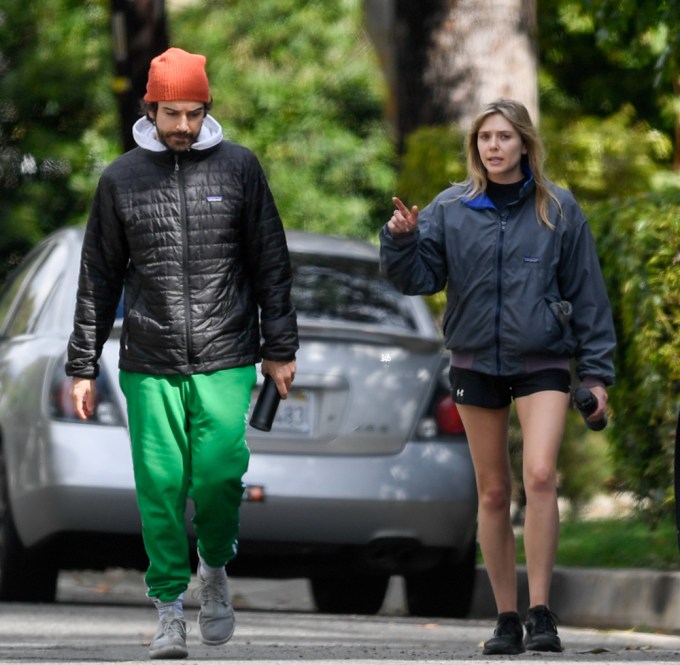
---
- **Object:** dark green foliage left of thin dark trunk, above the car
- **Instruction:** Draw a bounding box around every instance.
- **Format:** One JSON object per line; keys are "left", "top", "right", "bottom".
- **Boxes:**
{"left": 0, "top": 0, "right": 113, "bottom": 279}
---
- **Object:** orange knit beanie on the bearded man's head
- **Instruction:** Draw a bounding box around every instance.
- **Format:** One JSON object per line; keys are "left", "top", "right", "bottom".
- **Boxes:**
{"left": 144, "top": 47, "right": 210, "bottom": 103}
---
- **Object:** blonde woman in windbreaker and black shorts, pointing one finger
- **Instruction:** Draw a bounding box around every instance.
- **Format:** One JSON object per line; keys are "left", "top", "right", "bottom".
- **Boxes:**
{"left": 380, "top": 99, "right": 615, "bottom": 655}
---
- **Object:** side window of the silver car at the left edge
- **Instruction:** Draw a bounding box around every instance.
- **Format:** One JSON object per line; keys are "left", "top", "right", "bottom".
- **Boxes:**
{"left": 0, "top": 245, "right": 67, "bottom": 337}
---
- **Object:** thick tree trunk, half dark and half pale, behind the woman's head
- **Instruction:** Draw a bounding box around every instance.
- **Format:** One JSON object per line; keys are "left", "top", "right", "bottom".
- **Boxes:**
{"left": 365, "top": 0, "right": 538, "bottom": 151}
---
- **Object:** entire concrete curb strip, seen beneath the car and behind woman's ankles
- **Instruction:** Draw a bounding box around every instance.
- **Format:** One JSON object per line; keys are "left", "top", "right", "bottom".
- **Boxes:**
{"left": 57, "top": 566, "right": 680, "bottom": 633}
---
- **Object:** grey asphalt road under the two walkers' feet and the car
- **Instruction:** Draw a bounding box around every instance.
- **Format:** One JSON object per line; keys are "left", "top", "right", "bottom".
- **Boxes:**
{"left": 0, "top": 571, "right": 680, "bottom": 665}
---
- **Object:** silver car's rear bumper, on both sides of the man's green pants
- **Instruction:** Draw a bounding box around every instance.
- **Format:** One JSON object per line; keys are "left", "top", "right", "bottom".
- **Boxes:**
{"left": 13, "top": 422, "right": 477, "bottom": 551}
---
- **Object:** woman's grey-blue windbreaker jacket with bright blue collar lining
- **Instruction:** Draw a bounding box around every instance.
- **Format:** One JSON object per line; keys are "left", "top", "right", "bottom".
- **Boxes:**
{"left": 380, "top": 179, "right": 616, "bottom": 385}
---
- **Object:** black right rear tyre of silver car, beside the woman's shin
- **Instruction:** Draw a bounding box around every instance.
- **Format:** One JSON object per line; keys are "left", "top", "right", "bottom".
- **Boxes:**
{"left": 405, "top": 543, "right": 477, "bottom": 619}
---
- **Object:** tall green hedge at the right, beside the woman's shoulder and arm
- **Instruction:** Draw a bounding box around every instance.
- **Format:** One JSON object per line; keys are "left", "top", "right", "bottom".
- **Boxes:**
{"left": 541, "top": 101, "right": 680, "bottom": 519}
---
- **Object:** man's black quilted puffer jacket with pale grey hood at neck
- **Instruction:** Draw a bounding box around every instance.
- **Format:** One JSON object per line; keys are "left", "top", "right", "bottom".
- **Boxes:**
{"left": 66, "top": 116, "right": 298, "bottom": 377}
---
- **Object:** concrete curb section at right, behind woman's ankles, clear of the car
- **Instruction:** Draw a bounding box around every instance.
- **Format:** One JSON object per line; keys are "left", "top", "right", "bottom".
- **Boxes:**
{"left": 468, "top": 566, "right": 680, "bottom": 632}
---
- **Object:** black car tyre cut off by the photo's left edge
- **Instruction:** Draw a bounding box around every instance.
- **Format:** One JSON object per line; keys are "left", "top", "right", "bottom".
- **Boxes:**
{"left": 0, "top": 447, "right": 59, "bottom": 603}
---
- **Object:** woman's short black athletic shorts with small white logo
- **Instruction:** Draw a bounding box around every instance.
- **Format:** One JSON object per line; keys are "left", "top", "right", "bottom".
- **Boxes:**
{"left": 449, "top": 367, "right": 571, "bottom": 409}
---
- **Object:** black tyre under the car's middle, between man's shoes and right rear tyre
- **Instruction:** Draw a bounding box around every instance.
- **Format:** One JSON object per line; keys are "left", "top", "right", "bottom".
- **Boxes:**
{"left": 310, "top": 573, "right": 390, "bottom": 614}
